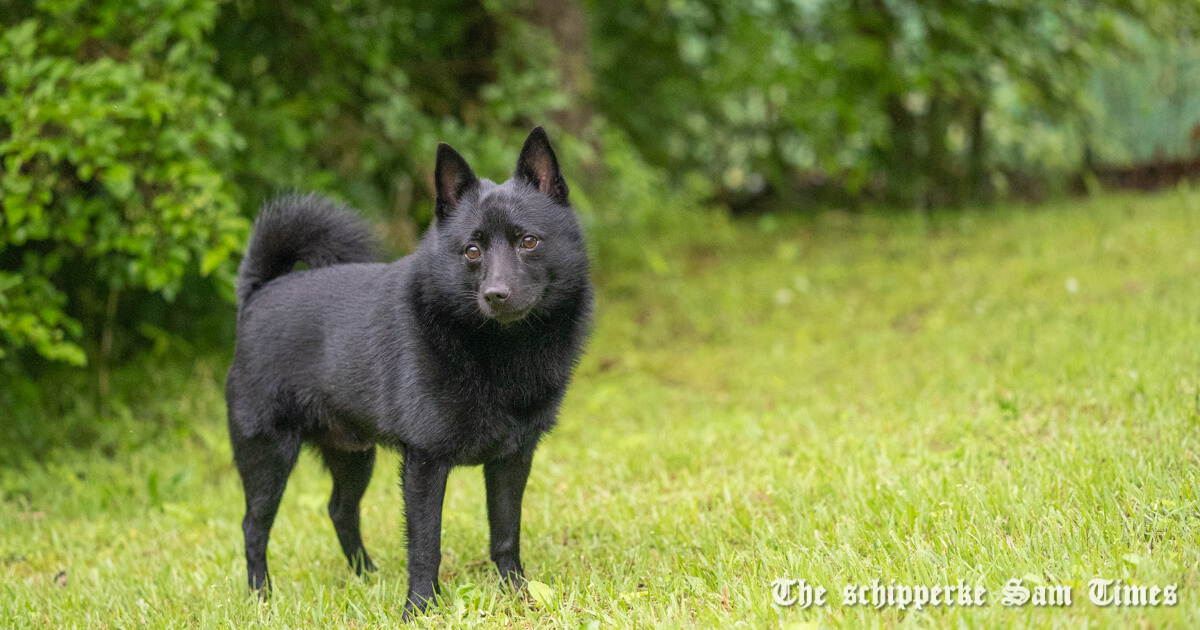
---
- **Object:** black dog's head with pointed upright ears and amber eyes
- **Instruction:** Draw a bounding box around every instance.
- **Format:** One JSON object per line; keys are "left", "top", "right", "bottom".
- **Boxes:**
{"left": 432, "top": 127, "right": 588, "bottom": 324}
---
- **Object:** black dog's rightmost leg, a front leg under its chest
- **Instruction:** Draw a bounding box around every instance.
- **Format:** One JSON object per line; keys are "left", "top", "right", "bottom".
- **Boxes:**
{"left": 484, "top": 449, "right": 533, "bottom": 588}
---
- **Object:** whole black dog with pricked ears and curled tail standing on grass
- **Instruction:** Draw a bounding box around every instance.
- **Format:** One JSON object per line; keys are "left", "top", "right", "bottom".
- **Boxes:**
{"left": 226, "top": 127, "right": 592, "bottom": 613}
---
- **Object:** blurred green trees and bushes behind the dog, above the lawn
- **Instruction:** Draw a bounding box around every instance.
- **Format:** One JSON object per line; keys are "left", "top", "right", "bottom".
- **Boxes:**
{"left": 0, "top": 0, "right": 1200, "bottom": 464}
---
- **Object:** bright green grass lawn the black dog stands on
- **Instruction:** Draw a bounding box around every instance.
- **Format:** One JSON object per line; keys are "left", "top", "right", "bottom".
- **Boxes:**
{"left": 0, "top": 191, "right": 1200, "bottom": 628}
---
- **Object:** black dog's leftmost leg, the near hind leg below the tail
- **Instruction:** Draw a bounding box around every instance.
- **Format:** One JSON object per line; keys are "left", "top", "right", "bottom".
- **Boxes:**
{"left": 234, "top": 432, "right": 300, "bottom": 596}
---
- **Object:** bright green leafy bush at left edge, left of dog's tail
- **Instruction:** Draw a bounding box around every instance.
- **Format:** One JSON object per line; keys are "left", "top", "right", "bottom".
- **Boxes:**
{"left": 0, "top": 0, "right": 247, "bottom": 365}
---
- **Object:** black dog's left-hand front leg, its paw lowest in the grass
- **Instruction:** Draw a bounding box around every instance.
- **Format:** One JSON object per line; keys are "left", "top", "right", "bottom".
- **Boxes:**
{"left": 400, "top": 449, "right": 450, "bottom": 616}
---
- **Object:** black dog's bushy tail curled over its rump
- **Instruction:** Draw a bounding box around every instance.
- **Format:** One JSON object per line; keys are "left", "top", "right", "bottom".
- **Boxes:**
{"left": 238, "top": 194, "right": 379, "bottom": 307}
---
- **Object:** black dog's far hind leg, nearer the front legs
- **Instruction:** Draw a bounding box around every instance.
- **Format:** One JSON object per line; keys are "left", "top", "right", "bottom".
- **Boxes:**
{"left": 320, "top": 446, "right": 376, "bottom": 576}
